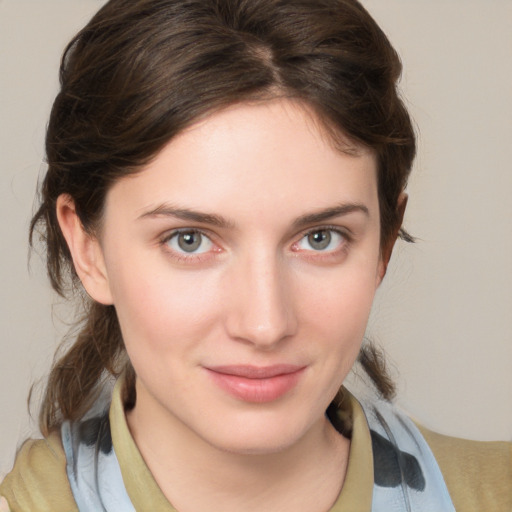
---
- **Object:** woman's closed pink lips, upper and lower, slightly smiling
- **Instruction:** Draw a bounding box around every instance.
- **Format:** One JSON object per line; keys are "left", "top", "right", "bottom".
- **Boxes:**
{"left": 205, "top": 364, "right": 305, "bottom": 403}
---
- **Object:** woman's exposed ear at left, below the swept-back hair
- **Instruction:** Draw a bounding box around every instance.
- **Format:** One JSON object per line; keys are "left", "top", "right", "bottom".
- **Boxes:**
{"left": 56, "top": 194, "right": 113, "bottom": 305}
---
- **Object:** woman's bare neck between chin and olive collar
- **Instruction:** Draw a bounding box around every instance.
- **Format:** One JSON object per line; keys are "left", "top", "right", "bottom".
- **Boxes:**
{"left": 127, "top": 386, "right": 350, "bottom": 512}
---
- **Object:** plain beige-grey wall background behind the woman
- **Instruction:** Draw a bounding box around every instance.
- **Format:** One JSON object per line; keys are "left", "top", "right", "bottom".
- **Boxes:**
{"left": 0, "top": 0, "right": 512, "bottom": 473}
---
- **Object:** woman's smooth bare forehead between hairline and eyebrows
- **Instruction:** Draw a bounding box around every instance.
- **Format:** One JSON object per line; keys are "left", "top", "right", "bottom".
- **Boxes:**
{"left": 107, "top": 100, "right": 377, "bottom": 223}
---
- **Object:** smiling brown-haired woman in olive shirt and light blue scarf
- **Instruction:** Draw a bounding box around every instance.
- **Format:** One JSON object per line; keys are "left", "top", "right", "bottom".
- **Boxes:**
{"left": 0, "top": 0, "right": 511, "bottom": 512}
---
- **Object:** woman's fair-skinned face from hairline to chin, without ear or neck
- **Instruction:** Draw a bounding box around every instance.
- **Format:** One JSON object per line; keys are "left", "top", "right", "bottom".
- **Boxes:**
{"left": 100, "top": 100, "right": 383, "bottom": 453}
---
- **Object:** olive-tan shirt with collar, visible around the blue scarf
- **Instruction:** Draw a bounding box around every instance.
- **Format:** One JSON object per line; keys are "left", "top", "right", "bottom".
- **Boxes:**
{"left": 0, "top": 383, "right": 512, "bottom": 512}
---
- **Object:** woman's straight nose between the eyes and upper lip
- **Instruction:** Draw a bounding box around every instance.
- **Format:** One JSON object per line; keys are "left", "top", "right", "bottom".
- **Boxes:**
{"left": 226, "top": 251, "right": 297, "bottom": 350}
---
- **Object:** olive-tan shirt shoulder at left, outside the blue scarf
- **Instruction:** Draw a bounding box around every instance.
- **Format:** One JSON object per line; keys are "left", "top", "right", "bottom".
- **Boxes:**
{"left": 0, "top": 432, "right": 78, "bottom": 512}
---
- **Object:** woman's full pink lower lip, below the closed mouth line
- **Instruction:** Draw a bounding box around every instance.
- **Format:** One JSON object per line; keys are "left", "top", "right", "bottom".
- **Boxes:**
{"left": 208, "top": 368, "right": 304, "bottom": 403}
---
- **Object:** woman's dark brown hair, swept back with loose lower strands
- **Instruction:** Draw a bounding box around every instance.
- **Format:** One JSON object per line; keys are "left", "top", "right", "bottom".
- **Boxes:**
{"left": 30, "top": 0, "right": 415, "bottom": 433}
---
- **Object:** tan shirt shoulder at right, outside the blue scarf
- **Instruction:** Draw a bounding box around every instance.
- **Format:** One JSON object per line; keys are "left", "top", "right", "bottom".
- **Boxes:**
{"left": 418, "top": 425, "right": 512, "bottom": 512}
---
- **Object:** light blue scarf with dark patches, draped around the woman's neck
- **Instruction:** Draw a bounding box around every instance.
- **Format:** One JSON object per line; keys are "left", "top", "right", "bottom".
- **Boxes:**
{"left": 62, "top": 388, "right": 455, "bottom": 512}
